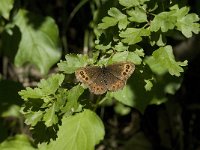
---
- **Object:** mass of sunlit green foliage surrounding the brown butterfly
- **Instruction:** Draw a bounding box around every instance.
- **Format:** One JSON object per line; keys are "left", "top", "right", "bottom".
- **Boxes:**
{"left": 0, "top": 0, "right": 200, "bottom": 150}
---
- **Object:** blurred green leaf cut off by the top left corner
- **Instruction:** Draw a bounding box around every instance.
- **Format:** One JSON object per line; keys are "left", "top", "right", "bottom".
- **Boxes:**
{"left": 0, "top": 0, "right": 14, "bottom": 20}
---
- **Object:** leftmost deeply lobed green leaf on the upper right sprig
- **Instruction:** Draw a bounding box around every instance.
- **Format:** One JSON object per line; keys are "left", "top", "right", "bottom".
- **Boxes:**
{"left": 98, "top": 7, "right": 129, "bottom": 30}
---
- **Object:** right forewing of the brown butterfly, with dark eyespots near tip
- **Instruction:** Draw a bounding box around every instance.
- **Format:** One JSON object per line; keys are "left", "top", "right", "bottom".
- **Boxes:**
{"left": 106, "top": 62, "right": 135, "bottom": 82}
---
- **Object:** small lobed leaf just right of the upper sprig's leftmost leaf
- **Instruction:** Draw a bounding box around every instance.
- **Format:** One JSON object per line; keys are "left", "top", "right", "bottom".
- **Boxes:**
{"left": 127, "top": 7, "right": 147, "bottom": 23}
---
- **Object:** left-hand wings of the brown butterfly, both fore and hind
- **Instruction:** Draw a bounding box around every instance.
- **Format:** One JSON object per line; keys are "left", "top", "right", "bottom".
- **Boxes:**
{"left": 75, "top": 66, "right": 107, "bottom": 95}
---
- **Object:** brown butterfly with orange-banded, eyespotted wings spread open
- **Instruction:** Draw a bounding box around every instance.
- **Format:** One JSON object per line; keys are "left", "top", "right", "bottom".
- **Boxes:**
{"left": 75, "top": 62, "right": 135, "bottom": 95}
